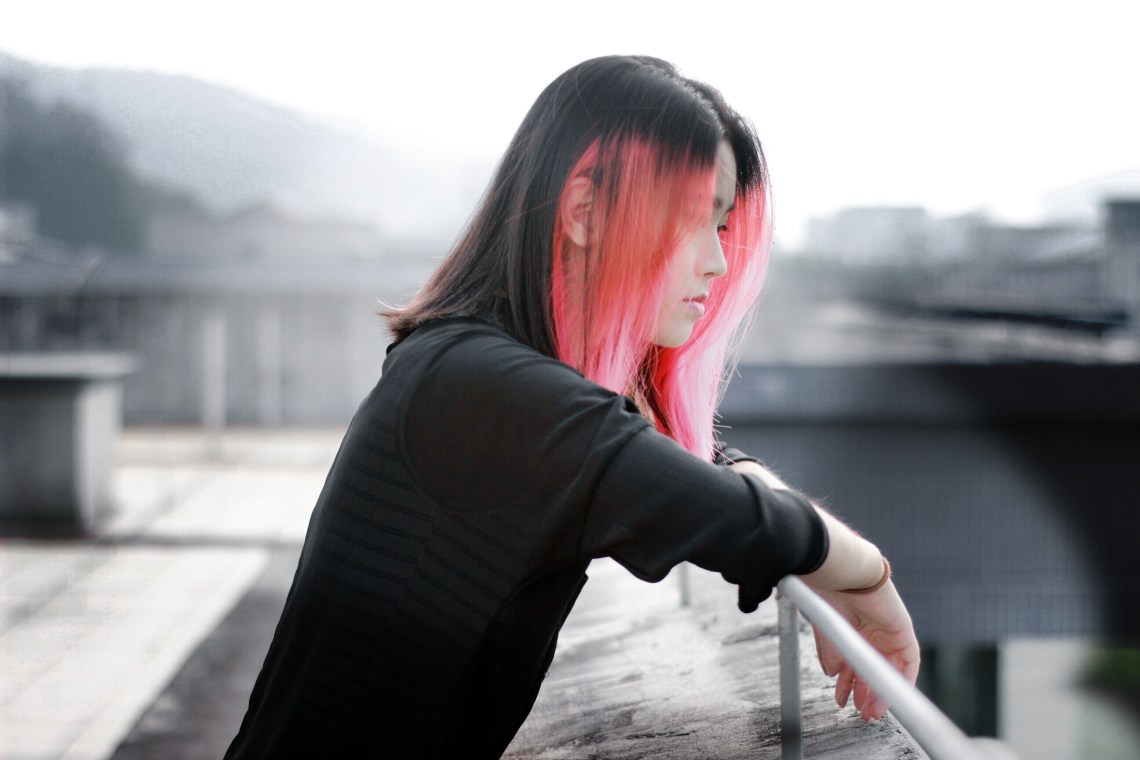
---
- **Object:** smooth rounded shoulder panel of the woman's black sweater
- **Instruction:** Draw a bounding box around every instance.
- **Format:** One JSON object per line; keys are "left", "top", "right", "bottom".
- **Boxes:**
{"left": 390, "top": 320, "right": 649, "bottom": 509}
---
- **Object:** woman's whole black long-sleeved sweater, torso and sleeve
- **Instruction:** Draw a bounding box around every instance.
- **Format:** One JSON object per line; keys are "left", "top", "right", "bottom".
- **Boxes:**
{"left": 226, "top": 318, "right": 827, "bottom": 760}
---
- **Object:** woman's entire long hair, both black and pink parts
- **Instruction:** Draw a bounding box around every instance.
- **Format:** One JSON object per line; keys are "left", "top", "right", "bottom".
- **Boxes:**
{"left": 384, "top": 56, "right": 772, "bottom": 458}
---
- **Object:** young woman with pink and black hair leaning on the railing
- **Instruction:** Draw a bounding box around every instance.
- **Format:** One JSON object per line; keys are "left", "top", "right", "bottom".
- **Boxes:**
{"left": 227, "top": 57, "right": 918, "bottom": 760}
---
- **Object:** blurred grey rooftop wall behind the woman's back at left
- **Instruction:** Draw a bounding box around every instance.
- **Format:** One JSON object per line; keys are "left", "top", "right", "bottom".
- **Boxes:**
{"left": 0, "top": 255, "right": 430, "bottom": 426}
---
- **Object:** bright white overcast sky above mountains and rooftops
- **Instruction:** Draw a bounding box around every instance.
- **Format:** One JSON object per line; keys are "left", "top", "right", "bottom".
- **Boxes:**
{"left": 0, "top": 0, "right": 1140, "bottom": 244}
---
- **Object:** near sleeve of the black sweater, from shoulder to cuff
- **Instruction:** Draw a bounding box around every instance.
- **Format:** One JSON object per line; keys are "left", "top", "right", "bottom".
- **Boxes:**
{"left": 406, "top": 319, "right": 827, "bottom": 598}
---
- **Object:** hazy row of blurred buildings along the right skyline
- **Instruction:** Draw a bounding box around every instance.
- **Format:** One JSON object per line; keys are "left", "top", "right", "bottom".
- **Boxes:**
{"left": 807, "top": 197, "right": 1140, "bottom": 332}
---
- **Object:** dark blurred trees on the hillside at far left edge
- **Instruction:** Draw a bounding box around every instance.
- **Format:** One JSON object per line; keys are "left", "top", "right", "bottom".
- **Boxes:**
{"left": 0, "top": 80, "right": 147, "bottom": 253}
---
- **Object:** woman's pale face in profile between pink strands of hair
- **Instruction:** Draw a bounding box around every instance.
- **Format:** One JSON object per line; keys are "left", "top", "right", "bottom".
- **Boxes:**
{"left": 653, "top": 140, "right": 736, "bottom": 348}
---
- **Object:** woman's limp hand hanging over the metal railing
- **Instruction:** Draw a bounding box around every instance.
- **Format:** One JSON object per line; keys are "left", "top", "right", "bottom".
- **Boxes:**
{"left": 812, "top": 581, "right": 919, "bottom": 720}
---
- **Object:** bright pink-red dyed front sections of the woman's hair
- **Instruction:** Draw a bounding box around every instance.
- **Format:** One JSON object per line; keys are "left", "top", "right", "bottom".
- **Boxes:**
{"left": 551, "top": 136, "right": 772, "bottom": 459}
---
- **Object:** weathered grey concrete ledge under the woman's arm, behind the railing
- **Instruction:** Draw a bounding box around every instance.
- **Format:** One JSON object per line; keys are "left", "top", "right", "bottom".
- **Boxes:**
{"left": 504, "top": 561, "right": 927, "bottom": 760}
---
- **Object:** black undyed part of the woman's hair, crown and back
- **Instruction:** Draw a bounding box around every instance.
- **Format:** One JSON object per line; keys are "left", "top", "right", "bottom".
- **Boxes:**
{"left": 382, "top": 56, "right": 766, "bottom": 357}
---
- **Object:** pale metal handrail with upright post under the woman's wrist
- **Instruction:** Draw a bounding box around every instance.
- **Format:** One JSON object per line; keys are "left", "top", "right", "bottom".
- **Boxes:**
{"left": 777, "top": 575, "right": 1016, "bottom": 760}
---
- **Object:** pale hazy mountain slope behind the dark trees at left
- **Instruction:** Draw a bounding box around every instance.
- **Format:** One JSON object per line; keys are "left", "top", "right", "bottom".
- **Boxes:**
{"left": 0, "top": 54, "right": 490, "bottom": 247}
